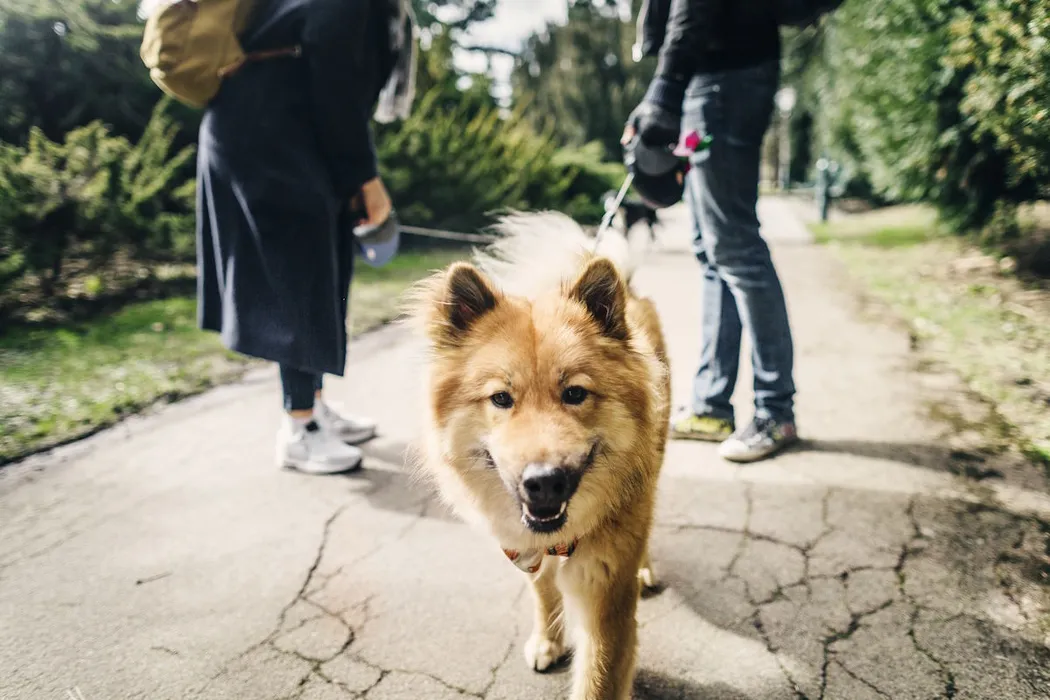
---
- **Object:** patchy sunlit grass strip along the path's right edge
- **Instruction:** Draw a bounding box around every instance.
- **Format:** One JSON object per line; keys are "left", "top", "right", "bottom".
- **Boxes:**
{"left": 813, "top": 206, "right": 1050, "bottom": 467}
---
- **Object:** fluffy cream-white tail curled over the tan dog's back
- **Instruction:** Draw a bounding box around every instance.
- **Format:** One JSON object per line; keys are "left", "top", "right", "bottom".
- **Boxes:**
{"left": 475, "top": 212, "right": 636, "bottom": 297}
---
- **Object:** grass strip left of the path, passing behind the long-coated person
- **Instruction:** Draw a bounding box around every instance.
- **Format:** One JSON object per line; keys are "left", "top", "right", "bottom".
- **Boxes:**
{"left": 0, "top": 251, "right": 463, "bottom": 465}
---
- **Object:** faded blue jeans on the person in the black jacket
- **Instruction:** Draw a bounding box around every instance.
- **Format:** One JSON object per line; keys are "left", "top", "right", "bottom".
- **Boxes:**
{"left": 683, "top": 62, "right": 795, "bottom": 421}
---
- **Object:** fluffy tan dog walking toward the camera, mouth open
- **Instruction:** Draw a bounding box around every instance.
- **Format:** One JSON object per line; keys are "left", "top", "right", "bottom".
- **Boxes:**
{"left": 412, "top": 213, "right": 670, "bottom": 700}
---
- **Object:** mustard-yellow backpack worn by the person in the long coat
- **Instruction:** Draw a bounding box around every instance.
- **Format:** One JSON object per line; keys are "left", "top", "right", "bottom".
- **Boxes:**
{"left": 140, "top": 0, "right": 257, "bottom": 108}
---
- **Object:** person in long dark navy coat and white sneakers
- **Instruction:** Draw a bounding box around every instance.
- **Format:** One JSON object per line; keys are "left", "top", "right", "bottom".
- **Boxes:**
{"left": 197, "top": 0, "right": 412, "bottom": 473}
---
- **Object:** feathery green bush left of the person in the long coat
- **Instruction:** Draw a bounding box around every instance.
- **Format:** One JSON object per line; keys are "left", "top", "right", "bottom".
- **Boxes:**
{"left": 0, "top": 103, "right": 193, "bottom": 297}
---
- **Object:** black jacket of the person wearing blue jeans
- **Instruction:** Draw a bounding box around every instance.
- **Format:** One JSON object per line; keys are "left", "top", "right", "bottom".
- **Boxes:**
{"left": 638, "top": 0, "right": 780, "bottom": 83}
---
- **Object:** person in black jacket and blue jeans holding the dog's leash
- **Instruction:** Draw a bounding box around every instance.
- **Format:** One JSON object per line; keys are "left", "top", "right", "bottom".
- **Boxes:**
{"left": 625, "top": 0, "right": 798, "bottom": 462}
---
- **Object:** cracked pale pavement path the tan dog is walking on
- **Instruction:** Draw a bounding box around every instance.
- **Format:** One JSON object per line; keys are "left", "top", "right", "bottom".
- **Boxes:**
{"left": 0, "top": 200, "right": 1050, "bottom": 700}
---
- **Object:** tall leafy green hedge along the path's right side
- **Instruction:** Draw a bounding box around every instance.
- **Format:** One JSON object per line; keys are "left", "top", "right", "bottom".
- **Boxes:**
{"left": 785, "top": 0, "right": 1050, "bottom": 235}
